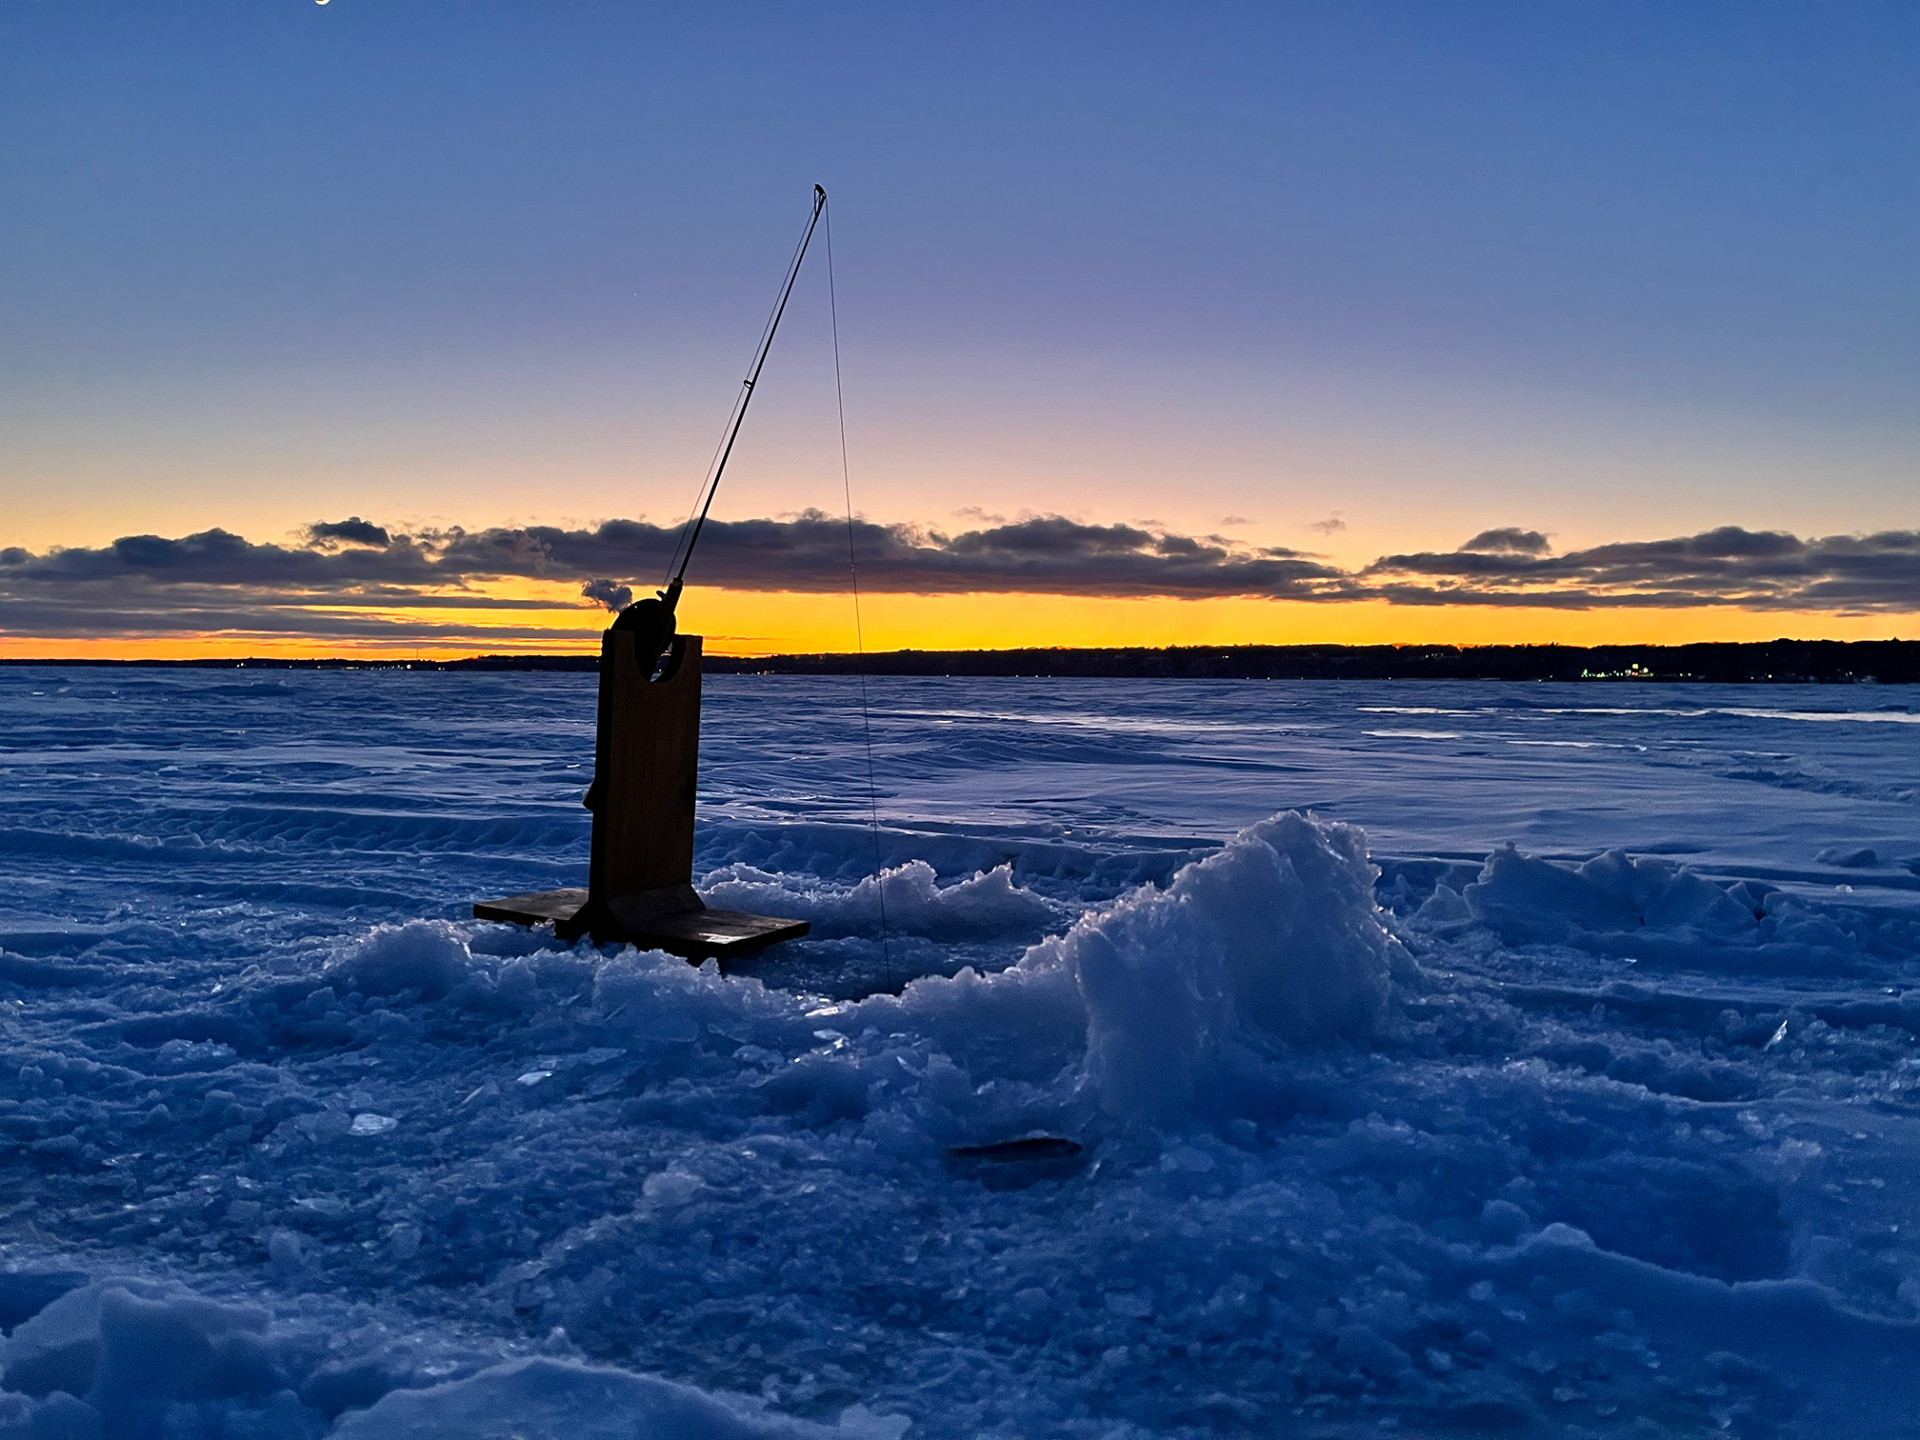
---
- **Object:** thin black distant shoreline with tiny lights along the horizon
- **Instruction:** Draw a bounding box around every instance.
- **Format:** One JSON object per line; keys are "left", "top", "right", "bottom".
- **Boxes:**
{"left": 0, "top": 639, "right": 1920, "bottom": 685}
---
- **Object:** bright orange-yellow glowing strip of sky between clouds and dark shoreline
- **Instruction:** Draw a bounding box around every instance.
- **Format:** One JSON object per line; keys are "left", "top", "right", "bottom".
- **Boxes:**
{"left": 0, "top": 584, "right": 1920, "bottom": 660}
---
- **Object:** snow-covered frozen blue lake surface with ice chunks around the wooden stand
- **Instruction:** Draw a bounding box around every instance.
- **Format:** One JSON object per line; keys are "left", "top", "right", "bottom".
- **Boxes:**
{"left": 0, "top": 668, "right": 1920, "bottom": 1440}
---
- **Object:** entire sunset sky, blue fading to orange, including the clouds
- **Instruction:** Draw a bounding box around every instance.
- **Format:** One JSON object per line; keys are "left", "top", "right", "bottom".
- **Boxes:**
{"left": 0, "top": 0, "right": 1920, "bottom": 657}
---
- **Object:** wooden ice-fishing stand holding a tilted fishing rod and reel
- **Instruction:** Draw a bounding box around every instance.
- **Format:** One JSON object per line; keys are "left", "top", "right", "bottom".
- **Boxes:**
{"left": 474, "top": 184, "right": 828, "bottom": 960}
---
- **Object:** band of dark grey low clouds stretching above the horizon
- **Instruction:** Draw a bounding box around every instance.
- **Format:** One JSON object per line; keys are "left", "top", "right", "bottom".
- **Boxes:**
{"left": 0, "top": 511, "right": 1920, "bottom": 641}
